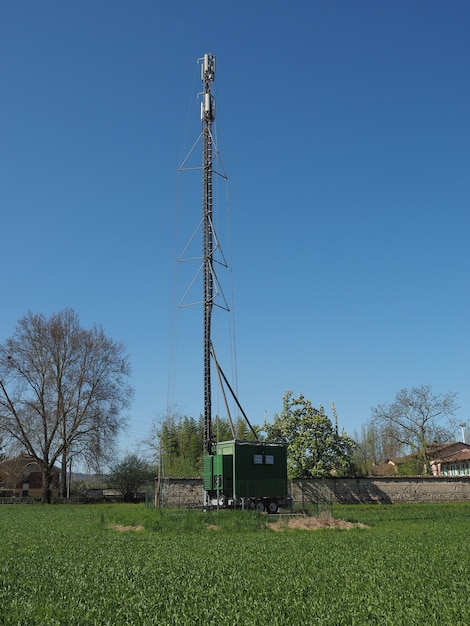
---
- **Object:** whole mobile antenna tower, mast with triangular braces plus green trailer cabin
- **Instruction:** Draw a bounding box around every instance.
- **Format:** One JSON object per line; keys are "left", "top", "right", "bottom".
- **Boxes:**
{"left": 179, "top": 54, "right": 289, "bottom": 513}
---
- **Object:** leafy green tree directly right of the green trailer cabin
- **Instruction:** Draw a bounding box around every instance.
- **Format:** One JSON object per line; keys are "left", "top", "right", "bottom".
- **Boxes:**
{"left": 267, "top": 391, "right": 355, "bottom": 478}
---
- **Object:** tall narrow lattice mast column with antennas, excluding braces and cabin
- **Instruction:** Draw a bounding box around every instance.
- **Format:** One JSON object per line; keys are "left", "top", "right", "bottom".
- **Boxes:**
{"left": 201, "top": 54, "right": 215, "bottom": 454}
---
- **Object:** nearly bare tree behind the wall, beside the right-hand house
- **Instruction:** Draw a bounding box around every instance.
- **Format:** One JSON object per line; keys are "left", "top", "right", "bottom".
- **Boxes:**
{"left": 372, "top": 385, "right": 458, "bottom": 472}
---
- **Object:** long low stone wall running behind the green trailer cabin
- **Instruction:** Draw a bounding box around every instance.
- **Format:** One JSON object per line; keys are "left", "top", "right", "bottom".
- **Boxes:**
{"left": 160, "top": 477, "right": 470, "bottom": 507}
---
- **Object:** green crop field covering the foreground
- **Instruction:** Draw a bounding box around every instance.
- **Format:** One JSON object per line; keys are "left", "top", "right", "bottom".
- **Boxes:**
{"left": 0, "top": 503, "right": 470, "bottom": 626}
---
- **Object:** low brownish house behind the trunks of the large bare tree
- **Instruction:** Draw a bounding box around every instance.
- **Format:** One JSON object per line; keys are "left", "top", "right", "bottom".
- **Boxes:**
{"left": 0, "top": 454, "right": 60, "bottom": 500}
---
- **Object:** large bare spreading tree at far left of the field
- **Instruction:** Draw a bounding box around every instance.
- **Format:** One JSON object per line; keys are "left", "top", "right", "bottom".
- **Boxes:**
{"left": 0, "top": 309, "right": 133, "bottom": 502}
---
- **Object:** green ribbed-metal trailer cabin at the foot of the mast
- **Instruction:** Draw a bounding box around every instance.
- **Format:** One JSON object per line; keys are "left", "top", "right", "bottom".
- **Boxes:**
{"left": 204, "top": 439, "right": 289, "bottom": 513}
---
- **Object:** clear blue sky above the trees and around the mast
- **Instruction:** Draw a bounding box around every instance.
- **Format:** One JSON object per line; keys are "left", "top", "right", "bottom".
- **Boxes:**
{"left": 0, "top": 0, "right": 470, "bottom": 458}
